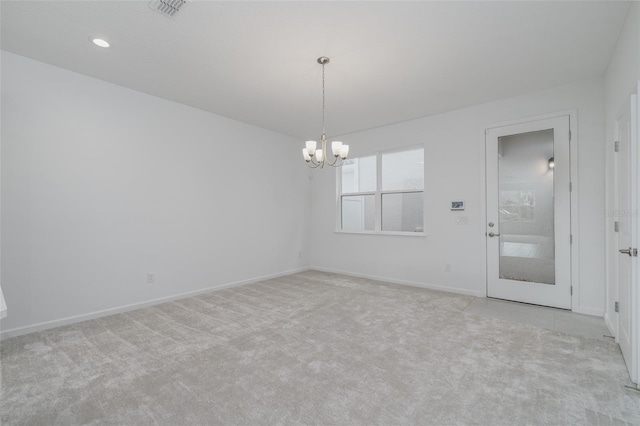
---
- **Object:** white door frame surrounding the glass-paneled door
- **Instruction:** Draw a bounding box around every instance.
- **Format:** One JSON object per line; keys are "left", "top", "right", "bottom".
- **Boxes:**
{"left": 478, "top": 109, "right": 580, "bottom": 315}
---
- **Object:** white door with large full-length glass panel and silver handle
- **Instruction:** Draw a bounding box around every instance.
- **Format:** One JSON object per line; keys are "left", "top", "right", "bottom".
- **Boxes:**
{"left": 486, "top": 115, "right": 571, "bottom": 309}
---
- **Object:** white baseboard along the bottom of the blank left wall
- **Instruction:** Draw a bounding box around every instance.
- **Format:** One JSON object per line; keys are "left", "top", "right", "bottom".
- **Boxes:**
{"left": 0, "top": 267, "right": 309, "bottom": 340}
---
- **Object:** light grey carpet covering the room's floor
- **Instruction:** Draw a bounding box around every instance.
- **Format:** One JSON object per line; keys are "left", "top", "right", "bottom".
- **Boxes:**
{"left": 1, "top": 272, "right": 640, "bottom": 425}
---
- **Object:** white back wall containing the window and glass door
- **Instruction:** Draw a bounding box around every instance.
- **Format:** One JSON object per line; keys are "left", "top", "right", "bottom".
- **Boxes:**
{"left": 311, "top": 80, "right": 605, "bottom": 315}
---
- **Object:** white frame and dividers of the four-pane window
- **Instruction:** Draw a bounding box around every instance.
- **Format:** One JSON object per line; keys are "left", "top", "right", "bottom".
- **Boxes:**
{"left": 335, "top": 144, "right": 427, "bottom": 237}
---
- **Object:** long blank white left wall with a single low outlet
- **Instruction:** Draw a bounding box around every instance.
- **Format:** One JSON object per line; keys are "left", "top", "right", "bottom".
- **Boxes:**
{"left": 1, "top": 52, "right": 309, "bottom": 337}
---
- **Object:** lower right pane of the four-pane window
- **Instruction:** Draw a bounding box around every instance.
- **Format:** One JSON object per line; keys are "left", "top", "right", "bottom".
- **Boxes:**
{"left": 382, "top": 192, "right": 424, "bottom": 232}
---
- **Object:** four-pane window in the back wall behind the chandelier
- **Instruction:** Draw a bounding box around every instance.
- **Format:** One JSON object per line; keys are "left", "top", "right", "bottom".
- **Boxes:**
{"left": 338, "top": 147, "right": 424, "bottom": 234}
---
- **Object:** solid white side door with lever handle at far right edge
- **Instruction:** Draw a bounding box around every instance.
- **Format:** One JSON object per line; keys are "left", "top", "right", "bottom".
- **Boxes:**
{"left": 616, "top": 95, "right": 638, "bottom": 382}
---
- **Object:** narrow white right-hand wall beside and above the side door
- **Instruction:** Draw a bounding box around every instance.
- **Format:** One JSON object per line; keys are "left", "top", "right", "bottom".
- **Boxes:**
{"left": 604, "top": 2, "right": 640, "bottom": 334}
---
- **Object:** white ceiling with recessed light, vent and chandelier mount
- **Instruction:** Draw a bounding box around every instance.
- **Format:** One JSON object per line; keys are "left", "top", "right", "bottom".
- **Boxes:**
{"left": 1, "top": 0, "right": 630, "bottom": 139}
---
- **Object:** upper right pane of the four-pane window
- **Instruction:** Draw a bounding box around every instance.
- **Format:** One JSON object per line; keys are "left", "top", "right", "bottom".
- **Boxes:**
{"left": 382, "top": 148, "right": 424, "bottom": 191}
